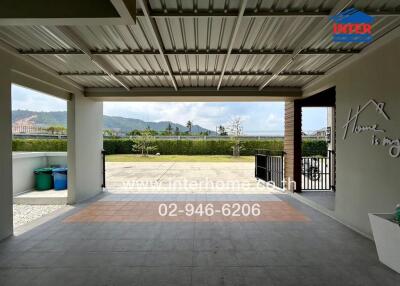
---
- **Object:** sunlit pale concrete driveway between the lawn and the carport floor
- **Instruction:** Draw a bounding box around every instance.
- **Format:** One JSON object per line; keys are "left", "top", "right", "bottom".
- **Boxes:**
{"left": 106, "top": 162, "right": 277, "bottom": 193}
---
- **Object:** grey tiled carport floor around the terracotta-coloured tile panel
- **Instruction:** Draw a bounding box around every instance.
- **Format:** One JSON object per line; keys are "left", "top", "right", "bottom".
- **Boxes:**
{"left": 0, "top": 195, "right": 400, "bottom": 286}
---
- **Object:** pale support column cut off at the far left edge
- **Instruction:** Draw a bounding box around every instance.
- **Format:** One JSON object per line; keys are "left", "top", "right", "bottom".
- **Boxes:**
{"left": 0, "top": 63, "right": 13, "bottom": 241}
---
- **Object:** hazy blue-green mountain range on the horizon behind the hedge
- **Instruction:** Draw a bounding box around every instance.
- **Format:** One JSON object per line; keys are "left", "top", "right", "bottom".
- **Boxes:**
{"left": 12, "top": 110, "right": 215, "bottom": 134}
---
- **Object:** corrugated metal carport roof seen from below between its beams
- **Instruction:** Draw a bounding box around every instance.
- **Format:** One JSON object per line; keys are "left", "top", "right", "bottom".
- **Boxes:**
{"left": 0, "top": 0, "right": 400, "bottom": 87}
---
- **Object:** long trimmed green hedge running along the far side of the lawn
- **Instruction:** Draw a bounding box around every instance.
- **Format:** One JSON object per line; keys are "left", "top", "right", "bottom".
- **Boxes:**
{"left": 13, "top": 139, "right": 327, "bottom": 156}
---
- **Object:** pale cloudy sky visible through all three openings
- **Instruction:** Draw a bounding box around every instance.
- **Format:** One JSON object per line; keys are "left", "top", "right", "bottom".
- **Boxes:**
{"left": 12, "top": 85, "right": 327, "bottom": 135}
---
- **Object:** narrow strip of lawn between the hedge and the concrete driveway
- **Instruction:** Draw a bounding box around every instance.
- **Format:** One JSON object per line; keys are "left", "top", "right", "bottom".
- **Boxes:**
{"left": 106, "top": 154, "right": 254, "bottom": 163}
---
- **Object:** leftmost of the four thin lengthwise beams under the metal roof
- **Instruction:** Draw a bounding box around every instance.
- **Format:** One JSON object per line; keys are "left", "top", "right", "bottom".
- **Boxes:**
{"left": 57, "top": 26, "right": 129, "bottom": 90}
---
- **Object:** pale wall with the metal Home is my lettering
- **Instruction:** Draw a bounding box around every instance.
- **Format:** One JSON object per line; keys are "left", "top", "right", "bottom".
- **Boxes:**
{"left": 304, "top": 34, "right": 400, "bottom": 235}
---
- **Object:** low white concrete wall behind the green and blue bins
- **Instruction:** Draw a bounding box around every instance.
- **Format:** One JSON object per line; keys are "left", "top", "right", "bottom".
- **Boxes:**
{"left": 13, "top": 152, "right": 67, "bottom": 196}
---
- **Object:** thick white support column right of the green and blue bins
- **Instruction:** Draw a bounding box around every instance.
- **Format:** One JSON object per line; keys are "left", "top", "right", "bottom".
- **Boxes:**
{"left": 68, "top": 94, "right": 103, "bottom": 204}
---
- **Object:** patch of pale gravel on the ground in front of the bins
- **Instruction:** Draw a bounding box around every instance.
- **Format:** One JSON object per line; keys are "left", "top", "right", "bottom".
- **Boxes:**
{"left": 14, "top": 205, "right": 65, "bottom": 228}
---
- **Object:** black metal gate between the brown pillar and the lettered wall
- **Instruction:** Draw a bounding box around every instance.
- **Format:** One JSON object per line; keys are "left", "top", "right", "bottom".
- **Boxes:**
{"left": 301, "top": 151, "right": 335, "bottom": 191}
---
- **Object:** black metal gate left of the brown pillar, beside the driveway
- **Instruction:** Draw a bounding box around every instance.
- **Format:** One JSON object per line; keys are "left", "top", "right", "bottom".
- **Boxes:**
{"left": 255, "top": 150, "right": 284, "bottom": 188}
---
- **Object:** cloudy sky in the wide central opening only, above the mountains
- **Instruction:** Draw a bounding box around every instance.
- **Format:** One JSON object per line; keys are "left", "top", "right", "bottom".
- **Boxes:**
{"left": 104, "top": 102, "right": 283, "bottom": 134}
